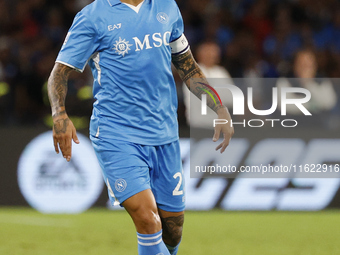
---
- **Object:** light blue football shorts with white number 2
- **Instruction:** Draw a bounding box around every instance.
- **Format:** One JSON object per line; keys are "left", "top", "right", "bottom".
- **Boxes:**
{"left": 90, "top": 136, "right": 185, "bottom": 212}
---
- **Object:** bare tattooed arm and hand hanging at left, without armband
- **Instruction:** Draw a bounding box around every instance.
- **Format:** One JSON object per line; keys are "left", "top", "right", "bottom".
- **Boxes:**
{"left": 47, "top": 63, "right": 79, "bottom": 161}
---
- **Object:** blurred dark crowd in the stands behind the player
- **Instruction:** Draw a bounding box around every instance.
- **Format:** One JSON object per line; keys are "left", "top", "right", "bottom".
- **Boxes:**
{"left": 0, "top": 0, "right": 340, "bottom": 128}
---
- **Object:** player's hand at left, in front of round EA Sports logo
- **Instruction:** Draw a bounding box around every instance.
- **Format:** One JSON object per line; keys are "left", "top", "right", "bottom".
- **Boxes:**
{"left": 53, "top": 113, "right": 79, "bottom": 161}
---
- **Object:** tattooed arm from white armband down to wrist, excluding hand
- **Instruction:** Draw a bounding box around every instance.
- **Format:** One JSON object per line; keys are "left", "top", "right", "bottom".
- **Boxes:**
{"left": 172, "top": 50, "right": 224, "bottom": 112}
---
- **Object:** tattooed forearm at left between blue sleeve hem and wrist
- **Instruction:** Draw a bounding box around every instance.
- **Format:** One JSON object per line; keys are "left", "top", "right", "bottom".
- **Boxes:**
{"left": 48, "top": 63, "right": 73, "bottom": 115}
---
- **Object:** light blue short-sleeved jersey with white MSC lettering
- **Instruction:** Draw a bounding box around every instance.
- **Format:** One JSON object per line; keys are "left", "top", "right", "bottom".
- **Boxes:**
{"left": 56, "top": 0, "right": 189, "bottom": 145}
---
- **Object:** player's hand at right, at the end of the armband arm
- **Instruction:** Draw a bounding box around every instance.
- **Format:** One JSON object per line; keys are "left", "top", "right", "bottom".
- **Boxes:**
{"left": 213, "top": 107, "right": 234, "bottom": 153}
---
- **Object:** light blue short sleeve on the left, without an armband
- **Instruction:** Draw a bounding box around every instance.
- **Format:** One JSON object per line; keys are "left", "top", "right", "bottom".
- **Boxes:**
{"left": 56, "top": 12, "right": 99, "bottom": 72}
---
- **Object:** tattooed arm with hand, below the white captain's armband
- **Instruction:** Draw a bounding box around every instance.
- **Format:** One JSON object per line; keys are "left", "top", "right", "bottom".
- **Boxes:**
{"left": 172, "top": 50, "right": 234, "bottom": 153}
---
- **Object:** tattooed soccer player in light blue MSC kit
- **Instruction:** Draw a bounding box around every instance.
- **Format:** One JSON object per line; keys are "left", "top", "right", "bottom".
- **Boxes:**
{"left": 48, "top": 0, "right": 233, "bottom": 255}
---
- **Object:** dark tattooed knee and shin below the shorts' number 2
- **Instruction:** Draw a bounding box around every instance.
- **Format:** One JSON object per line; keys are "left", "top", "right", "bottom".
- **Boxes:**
{"left": 161, "top": 214, "right": 184, "bottom": 246}
